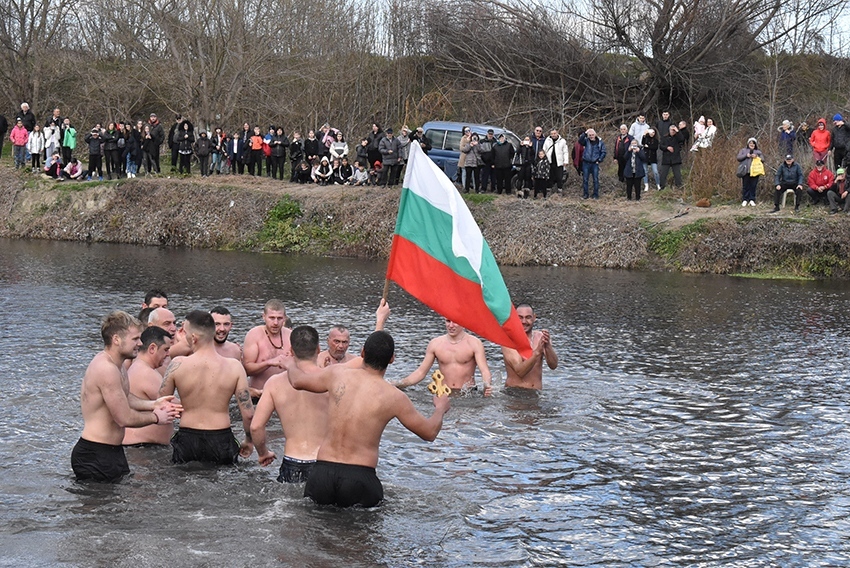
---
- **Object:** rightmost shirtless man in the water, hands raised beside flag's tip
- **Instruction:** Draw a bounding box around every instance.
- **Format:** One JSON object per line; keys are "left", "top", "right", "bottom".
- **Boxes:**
{"left": 502, "top": 304, "right": 558, "bottom": 390}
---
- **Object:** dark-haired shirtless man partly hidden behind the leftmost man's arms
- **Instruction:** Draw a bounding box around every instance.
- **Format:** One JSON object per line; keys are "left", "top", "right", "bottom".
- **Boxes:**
{"left": 123, "top": 325, "right": 174, "bottom": 446}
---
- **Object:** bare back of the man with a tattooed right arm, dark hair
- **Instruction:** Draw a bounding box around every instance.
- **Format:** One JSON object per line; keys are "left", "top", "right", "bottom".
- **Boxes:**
{"left": 163, "top": 349, "right": 245, "bottom": 430}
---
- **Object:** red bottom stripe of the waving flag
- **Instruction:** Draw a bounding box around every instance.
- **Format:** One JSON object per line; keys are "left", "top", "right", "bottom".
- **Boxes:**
{"left": 387, "top": 235, "right": 531, "bottom": 358}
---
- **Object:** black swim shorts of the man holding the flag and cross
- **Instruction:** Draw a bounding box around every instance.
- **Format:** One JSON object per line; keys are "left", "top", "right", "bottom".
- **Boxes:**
{"left": 304, "top": 460, "right": 384, "bottom": 507}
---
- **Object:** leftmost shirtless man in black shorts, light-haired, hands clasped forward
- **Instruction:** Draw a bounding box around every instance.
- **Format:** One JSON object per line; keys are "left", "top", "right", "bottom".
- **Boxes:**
{"left": 71, "top": 311, "right": 182, "bottom": 483}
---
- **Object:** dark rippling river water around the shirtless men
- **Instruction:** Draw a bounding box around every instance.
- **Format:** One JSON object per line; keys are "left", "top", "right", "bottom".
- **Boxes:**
{"left": 0, "top": 237, "right": 850, "bottom": 568}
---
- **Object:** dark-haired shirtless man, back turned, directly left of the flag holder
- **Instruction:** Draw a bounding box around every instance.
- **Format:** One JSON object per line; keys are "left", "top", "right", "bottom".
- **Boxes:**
{"left": 251, "top": 325, "right": 328, "bottom": 483}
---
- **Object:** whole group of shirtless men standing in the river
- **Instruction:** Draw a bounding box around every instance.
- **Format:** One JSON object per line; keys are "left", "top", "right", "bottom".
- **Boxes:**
{"left": 71, "top": 290, "right": 558, "bottom": 507}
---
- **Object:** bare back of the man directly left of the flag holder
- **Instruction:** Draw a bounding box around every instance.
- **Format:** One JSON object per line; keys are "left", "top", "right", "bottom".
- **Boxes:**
{"left": 263, "top": 371, "right": 328, "bottom": 460}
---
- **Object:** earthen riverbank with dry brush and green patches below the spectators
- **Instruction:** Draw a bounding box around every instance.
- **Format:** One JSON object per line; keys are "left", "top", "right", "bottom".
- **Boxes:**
{"left": 0, "top": 167, "right": 850, "bottom": 278}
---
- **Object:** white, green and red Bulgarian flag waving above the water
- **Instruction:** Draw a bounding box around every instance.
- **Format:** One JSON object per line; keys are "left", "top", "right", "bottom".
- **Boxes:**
{"left": 387, "top": 140, "right": 531, "bottom": 358}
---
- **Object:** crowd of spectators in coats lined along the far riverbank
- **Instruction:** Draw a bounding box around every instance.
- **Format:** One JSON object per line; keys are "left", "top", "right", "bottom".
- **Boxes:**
{"left": 0, "top": 103, "right": 850, "bottom": 212}
